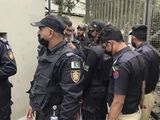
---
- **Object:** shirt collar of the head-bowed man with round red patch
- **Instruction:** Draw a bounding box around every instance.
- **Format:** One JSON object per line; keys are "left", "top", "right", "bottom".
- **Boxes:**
{"left": 113, "top": 47, "right": 131, "bottom": 61}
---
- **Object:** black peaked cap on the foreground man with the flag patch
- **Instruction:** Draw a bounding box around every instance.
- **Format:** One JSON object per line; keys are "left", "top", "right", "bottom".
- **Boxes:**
{"left": 31, "top": 15, "right": 65, "bottom": 34}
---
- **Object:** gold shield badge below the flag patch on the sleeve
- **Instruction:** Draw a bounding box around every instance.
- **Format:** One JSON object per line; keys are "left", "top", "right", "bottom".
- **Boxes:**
{"left": 71, "top": 70, "right": 81, "bottom": 83}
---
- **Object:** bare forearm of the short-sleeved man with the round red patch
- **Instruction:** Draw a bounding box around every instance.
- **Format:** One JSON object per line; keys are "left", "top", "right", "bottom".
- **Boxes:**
{"left": 108, "top": 101, "right": 123, "bottom": 120}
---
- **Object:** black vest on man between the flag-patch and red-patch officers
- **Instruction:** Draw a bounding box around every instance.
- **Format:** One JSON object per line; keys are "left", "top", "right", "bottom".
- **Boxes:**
{"left": 82, "top": 46, "right": 107, "bottom": 113}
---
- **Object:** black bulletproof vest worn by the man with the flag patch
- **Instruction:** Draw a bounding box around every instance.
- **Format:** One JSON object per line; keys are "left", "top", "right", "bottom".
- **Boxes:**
{"left": 30, "top": 47, "right": 73, "bottom": 111}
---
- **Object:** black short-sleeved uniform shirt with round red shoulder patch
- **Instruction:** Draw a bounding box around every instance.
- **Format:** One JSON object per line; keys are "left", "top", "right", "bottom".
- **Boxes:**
{"left": 108, "top": 47, "right": 145, "bottom": 114}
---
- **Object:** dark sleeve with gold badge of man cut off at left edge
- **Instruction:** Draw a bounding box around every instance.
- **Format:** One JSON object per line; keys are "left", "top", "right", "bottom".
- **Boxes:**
{"left": 0, "top": 42, "right": 17, "bottom": 81}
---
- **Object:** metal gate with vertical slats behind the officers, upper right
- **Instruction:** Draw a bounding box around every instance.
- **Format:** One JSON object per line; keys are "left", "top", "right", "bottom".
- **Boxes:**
{"left": 86, "top": 0, "right": 160, "bottom": 51}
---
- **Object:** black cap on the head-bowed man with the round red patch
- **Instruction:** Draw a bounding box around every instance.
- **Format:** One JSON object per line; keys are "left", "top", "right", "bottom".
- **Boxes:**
{"left": 99, "top": 25, "right": 124, "bottom": 43}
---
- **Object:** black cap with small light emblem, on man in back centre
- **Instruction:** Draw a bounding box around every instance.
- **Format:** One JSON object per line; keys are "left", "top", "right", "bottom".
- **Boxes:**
{"left": 89, "top": 20, "right": 106, "bottom": 32}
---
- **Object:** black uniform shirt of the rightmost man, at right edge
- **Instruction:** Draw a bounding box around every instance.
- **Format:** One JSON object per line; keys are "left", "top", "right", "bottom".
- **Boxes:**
{"left": 135, "top": 42, "right": 160, "bottom": 94}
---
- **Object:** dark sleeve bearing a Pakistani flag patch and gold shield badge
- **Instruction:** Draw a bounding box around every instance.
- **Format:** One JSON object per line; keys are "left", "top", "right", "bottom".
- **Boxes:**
{"left": 59, "top": 57, "right": 84, "bottom": 120}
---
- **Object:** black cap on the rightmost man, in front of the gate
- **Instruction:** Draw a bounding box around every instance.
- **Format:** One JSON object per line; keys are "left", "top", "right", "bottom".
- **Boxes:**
{"left": 129, "top": 24, "right": 147, "bottom": 40}
